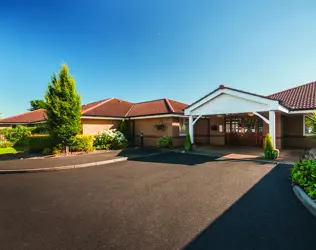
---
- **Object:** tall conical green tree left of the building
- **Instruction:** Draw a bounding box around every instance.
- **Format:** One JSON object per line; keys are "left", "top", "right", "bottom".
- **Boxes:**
{"left": 45, "top": 64, "right": 81, "bottom": 147}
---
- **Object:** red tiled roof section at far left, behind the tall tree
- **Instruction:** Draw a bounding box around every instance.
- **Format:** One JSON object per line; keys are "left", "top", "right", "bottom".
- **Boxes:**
{"left": 0, "top": 109, "right": 46, "bottom": 123}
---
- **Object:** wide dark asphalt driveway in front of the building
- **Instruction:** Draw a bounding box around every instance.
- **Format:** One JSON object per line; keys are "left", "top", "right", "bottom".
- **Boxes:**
{"left": 0, "top": 153, "right": 316, "bottom": 250}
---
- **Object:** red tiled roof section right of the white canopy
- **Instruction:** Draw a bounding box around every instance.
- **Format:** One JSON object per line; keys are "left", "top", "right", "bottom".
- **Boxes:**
{"left": 268, "top": 82, "right": 316, "bottom": 110}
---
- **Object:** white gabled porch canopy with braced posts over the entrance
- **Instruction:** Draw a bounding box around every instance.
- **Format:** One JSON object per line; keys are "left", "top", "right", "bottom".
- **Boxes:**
{"left": 184, "top": 85, "right": 289, "bottom": 147}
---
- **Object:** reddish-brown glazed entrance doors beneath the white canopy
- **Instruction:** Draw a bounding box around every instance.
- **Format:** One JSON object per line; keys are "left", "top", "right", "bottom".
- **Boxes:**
{"left": 225, "top": 116, "right": 263, "bottom": 147}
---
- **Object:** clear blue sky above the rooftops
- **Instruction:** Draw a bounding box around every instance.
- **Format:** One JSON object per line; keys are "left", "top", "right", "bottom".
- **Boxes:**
{"left": 0, "top": 0, "right": 316, "bottom": 117}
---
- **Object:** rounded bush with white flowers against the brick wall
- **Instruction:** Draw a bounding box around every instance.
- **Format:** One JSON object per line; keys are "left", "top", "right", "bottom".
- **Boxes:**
{"left": 94, "top": 129, "right": 127, "bottom": 150}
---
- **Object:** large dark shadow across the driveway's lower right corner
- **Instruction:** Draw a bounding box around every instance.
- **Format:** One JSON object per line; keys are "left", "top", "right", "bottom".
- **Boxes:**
{"left": 184, "top": 164, "right": 316, "bottom": 250}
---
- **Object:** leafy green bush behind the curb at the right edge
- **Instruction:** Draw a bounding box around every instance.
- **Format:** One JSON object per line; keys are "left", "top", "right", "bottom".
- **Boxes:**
{"left": 291, "top": 160, "right": 316, "bottom": 200}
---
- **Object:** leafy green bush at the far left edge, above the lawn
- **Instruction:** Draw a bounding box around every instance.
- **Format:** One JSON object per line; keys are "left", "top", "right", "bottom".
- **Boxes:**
{"left": 1, "top": 125, "right": 34, "bottom": 145}
